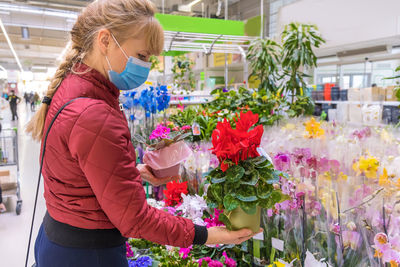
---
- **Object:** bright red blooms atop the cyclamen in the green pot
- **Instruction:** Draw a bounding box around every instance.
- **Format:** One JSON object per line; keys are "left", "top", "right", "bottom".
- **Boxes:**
{"left": 211, "top": 111, "right": 264, "bottom": 171}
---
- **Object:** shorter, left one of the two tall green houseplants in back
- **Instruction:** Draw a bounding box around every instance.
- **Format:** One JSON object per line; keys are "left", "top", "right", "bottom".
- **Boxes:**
{"left": 247, "top": 39, "right": 281, "bottom": 93}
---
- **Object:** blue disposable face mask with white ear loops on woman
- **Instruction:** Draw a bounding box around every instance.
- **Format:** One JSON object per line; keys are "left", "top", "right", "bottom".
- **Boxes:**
{"left": 106, "top": 34, "right": 151, "bottom": 90}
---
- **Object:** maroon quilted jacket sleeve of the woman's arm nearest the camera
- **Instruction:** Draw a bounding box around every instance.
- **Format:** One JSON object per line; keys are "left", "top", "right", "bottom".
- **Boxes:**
{"left": 68, "top": 103, "right": 195, "bottom": 247}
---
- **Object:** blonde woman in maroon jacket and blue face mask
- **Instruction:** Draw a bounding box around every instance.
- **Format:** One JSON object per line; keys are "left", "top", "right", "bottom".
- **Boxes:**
{"left": 27, "top": 0, "right": 258, "bottom": 267}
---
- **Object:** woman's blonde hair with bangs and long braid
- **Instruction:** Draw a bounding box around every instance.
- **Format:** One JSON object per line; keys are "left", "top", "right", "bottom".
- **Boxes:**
{"left": 26, "top": 0, "right": 164, "bottom": 141}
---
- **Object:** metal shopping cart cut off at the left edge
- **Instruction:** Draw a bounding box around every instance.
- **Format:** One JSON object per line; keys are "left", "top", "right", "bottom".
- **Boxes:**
{"left": 0, "top": 128, "right": 22, "bottom": 215}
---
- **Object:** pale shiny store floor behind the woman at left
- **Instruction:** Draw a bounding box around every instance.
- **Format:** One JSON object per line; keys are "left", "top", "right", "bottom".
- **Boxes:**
{"left": 0, "top": 102, "right": 45, "bottom": 267}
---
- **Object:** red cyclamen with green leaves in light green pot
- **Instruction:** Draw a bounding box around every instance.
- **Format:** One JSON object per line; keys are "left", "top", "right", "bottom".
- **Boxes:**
{"left": 207, "top": 111, "right": 284, "bottom": 232}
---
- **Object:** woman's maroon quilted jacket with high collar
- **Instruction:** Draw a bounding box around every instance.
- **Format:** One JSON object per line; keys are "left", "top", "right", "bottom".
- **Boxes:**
{"left": 43, "top": 64, "right": 195, "bottom": 247}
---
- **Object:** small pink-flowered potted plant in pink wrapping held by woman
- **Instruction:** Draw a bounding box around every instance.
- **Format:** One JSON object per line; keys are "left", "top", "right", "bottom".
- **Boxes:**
{"left": 134, "top": 124, "right": 192, "bottom": 178}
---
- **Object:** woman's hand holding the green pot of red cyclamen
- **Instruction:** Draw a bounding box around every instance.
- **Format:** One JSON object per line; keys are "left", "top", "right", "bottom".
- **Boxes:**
{"left": 206, "top": 227, "right": 263, "bottom": 245}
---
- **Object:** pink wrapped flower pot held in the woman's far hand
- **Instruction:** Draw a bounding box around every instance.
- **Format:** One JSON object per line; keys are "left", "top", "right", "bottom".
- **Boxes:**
{"left": 143, "top": 141, "right": 192, "bottom": 178}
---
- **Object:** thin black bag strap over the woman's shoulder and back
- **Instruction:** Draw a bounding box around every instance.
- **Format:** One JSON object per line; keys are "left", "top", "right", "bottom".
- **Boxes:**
{"left": 25, "top": 97, "right": 87, "bottom": 267}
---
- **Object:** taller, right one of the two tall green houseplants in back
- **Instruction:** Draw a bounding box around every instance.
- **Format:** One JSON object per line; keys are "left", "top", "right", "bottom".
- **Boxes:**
{"left": 281, "top": 23, "right": 325, "bottom": 116}
